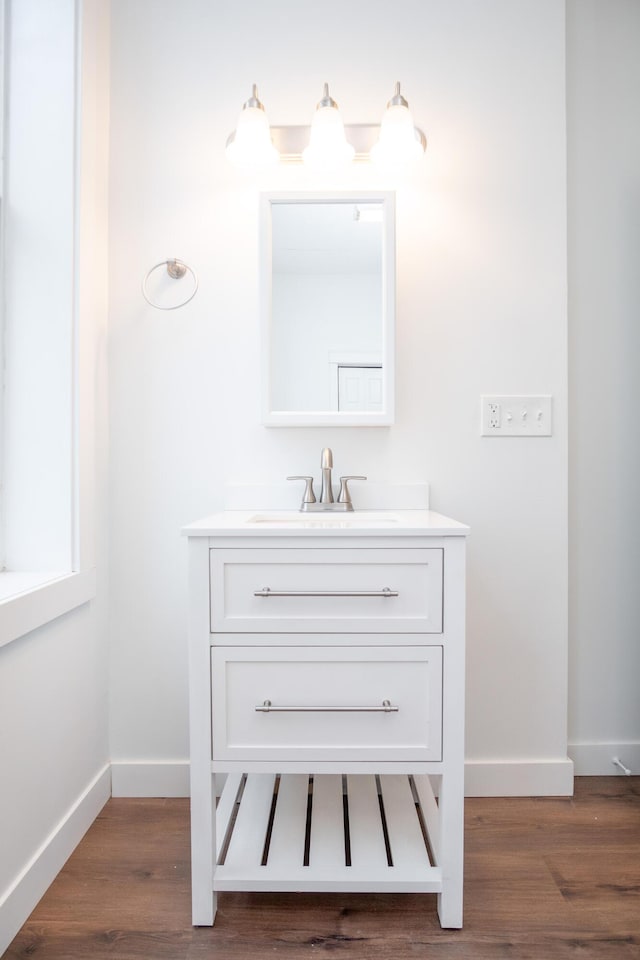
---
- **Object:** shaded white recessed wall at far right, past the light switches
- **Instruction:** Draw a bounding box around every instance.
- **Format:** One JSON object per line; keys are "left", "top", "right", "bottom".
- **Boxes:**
{"left": 567, "top": 0, "right": 640, "bottom": 774}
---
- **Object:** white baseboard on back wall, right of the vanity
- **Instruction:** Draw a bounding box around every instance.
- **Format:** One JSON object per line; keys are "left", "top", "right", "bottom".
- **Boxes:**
{"left": 464, "top": 758, "right": 574, "bottom": 797}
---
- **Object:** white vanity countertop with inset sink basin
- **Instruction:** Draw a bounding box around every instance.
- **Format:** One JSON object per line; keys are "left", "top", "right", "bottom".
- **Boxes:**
{"left": 182, "top": 510, "right": 469, "bottom": 537}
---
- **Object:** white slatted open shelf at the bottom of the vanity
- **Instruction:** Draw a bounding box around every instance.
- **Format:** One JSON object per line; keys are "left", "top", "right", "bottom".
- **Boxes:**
{"left": 213, "top": 773, "right": 442, "bottom": 893}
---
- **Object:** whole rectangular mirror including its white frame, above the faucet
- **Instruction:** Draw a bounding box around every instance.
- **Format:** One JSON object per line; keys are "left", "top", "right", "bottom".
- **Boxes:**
{"left": 260, "top": 192, "right": 395, "bottom": 426}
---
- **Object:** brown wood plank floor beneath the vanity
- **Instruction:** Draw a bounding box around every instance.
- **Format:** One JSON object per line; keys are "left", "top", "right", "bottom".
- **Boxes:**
{"left": 5, "top": 777, "right": 640, "bottom": 960}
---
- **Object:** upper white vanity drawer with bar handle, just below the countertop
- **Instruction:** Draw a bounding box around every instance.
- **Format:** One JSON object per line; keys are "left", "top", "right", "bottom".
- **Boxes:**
{"left": 209, "top": 547, "right": 443, "bottom": 633}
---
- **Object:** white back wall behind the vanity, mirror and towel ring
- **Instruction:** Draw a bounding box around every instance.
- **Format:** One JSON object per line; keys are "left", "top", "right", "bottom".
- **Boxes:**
{"left": 109, "top": 0, "right": 570, "bottom": 792}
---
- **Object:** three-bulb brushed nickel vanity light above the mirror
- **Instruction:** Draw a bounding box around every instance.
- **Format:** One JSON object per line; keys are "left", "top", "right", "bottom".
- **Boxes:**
{"left": 226, "top": 83, "right": 427, "bottom": 172}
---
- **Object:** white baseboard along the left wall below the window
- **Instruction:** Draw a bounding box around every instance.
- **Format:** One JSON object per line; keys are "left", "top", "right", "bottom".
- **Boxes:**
{"left": 0, "top": 764, "right": 111, "bottom": 956}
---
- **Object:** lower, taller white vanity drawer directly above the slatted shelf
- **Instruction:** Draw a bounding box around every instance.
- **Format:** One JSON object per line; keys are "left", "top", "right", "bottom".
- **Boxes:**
{"left": 211, "top": 646, "right": 442, "bottom": 763}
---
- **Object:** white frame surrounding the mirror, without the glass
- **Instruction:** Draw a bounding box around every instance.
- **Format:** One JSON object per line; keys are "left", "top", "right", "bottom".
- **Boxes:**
{"left": 260, "top": 191, "right": 396, "bottom": 427}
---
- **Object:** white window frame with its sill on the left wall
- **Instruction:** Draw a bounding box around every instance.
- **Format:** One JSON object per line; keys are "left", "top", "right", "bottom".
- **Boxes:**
{"left": 0, "top": 0, "right": 96, "bottom": 647}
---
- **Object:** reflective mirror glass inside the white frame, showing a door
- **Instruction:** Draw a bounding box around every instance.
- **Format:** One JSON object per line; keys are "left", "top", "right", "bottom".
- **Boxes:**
{"left": 271, "top": 202, "right": 382, "bottom": 410}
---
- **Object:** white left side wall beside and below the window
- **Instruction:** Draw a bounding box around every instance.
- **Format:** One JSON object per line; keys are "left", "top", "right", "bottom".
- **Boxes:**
{"left": 0, "top": 0, "right": 110, "bottom": 954}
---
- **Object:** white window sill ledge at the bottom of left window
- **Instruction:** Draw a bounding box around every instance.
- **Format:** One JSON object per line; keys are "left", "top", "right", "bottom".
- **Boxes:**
{"left": 0, "top": 570, "right": 96, "bottom": 647}
